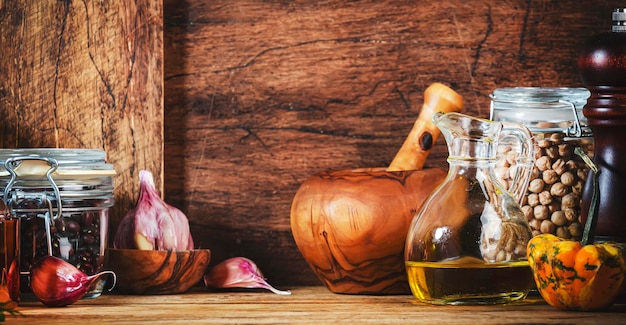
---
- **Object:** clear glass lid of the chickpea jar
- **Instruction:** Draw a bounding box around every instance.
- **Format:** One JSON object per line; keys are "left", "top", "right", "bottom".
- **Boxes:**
{"left": 490, "top": 87, "right": 591, "bottom": 137}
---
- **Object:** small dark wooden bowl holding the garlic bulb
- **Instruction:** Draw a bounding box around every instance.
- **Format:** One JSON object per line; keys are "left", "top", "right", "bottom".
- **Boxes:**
{"left": 106, "top": 249, "right": 211, "bottom": 295}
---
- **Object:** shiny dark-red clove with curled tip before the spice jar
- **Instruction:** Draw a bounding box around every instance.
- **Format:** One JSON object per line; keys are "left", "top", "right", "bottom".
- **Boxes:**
{"left": 30, "top": 256, "right": 116, "bottom": 307}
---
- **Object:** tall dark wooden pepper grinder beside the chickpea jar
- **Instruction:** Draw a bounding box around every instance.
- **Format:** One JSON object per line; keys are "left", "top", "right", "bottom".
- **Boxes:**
{"left": 578, "top": 8, "right": 626, "bottom": 243}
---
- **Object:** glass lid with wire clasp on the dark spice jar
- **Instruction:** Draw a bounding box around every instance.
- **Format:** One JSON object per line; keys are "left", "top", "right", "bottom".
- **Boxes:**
{"left": 0, "top": 148, "right": 116, "bottom": 217}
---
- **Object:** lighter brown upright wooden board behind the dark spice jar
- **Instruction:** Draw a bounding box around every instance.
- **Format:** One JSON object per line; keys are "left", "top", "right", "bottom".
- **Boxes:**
{"left": 0, "top": 0, "right": 163, "bottom": 229}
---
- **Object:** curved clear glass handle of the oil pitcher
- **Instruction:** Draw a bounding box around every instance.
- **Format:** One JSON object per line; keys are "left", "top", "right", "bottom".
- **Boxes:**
{"left": 498, "top": 122, "right": 535, "bottom": 205}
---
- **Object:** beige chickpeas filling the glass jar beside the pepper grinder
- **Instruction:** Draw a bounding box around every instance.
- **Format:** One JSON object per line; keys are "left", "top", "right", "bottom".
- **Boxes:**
{"left": 492, "top": 131, "right": 592, "bottom": 238}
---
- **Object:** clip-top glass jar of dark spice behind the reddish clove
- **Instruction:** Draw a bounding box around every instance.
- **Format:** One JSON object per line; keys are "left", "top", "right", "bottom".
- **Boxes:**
{"left": 0, "top": 148, "right": 115, "bottom": 298}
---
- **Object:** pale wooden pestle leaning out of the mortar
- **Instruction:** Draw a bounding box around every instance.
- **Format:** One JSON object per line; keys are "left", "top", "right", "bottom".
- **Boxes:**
{"left": 387, "top": 83, "right": 463, "bottom": 171}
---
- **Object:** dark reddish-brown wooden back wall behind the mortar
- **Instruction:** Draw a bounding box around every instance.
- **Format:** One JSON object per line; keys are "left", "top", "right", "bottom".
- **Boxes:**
{"left": 164, "top": 0, "right": 623, "bottom": 284}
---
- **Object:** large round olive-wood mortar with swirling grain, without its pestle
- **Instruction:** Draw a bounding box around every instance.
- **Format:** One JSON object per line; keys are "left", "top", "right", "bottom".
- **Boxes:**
{"left": 291, "top": 168, "right": 446, "bottom": 295}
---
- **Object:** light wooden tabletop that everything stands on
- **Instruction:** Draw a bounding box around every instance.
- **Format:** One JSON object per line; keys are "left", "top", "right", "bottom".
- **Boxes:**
{"left": 5, "top": 286, "right": 626, "bottom": 325}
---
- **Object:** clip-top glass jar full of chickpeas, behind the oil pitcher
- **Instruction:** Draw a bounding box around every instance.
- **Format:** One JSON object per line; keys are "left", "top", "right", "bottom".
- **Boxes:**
{"left": 490, "top": 87, "right": 593, "bottom": 239}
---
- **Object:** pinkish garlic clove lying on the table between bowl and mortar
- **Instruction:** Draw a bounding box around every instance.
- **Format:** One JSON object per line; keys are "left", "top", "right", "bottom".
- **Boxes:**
{"left": 203, "top": 257, "right": 291, "bottom": 295}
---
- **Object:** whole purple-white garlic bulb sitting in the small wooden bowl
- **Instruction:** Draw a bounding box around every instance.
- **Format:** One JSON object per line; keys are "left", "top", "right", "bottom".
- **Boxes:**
{"left": 113, "top": 170, "right": 193, "bottom": 251}
